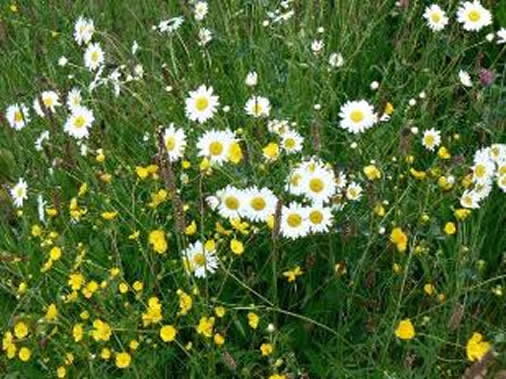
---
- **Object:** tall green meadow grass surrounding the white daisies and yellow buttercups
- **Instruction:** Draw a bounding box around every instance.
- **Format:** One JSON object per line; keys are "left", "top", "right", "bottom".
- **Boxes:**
{"left": 0, "top": 0, "right": 506, "bottom": 378}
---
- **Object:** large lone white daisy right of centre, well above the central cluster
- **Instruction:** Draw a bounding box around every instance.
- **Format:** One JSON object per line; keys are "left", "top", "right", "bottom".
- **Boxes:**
{"left": 339, "top": 100, "right": 378, "bottom": 134}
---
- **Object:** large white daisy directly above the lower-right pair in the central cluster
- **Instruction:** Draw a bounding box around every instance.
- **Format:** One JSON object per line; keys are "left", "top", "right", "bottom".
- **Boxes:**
{"left": 302, "top": 166, "right": 336, "bottom": 203}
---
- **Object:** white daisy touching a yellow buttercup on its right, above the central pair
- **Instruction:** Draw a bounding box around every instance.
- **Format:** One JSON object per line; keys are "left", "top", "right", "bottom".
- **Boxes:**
{"left": 197, "top": 129, "right": 236, "bottom": 164}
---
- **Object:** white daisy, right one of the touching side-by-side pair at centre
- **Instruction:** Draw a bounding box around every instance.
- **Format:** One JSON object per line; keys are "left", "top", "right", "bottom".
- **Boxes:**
{"left": 243, "top": 187, "right": 278, "bottom": 222}
